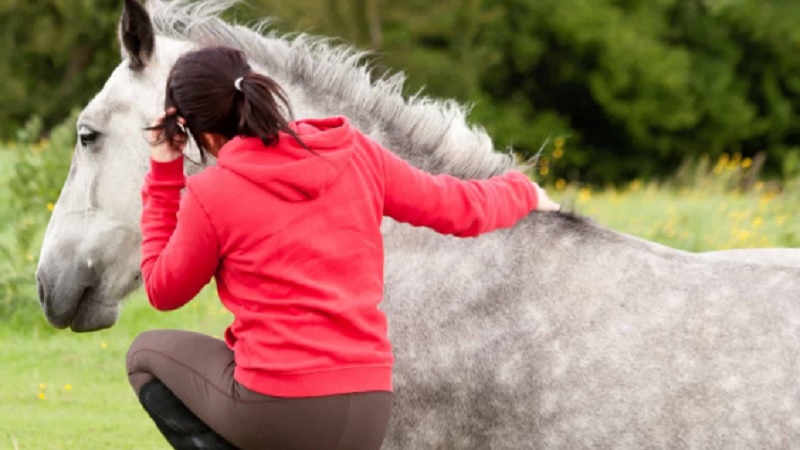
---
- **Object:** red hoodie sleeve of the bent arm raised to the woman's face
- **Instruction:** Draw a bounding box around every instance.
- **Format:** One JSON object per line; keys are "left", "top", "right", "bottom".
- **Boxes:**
{"left": 141, "top": 158, "right": 219, "bottom": 311}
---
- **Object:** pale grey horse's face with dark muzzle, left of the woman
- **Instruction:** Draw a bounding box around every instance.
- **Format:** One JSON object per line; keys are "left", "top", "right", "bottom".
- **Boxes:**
{"left": 36, "top": 0, "right": 189, "bottom": 331}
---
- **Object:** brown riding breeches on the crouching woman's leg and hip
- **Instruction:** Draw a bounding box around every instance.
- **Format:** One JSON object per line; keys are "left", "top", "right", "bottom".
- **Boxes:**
{"left": 128, "top": 330, "right": 391, "bottom": 450}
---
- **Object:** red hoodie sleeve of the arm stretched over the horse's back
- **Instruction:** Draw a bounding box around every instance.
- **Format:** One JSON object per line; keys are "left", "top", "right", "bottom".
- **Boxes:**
{"left": 374, "top": 143, "right": 537, "bottom": 237}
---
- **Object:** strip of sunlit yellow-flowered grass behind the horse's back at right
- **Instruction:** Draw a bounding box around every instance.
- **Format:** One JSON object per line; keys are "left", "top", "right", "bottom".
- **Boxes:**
{"left": 567, "top": 183, "right": 800, "bottom": 252}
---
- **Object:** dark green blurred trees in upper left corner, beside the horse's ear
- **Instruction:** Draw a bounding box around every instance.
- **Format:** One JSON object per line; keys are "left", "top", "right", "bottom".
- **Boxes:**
{"left": 0, "top": 0, "right": 122, "bottom": 138}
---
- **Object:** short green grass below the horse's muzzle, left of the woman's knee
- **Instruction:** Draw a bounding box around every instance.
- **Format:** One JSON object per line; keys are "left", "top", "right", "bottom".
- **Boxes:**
{"left": 0, "top": 292, "right": 229, "bottom": 450}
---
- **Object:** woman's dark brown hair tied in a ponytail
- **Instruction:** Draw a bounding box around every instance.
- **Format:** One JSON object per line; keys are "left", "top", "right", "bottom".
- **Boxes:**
{"left": 150, "top": 47, "right": 308, "bottom": 161}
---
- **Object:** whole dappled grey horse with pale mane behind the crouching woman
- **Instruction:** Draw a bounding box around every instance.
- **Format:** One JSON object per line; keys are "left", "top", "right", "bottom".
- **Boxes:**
{"left": 37, "top": 0, "right": 800, "bottom": 450}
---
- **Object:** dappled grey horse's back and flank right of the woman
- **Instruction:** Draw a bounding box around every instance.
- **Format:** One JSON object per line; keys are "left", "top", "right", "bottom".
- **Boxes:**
{"left": 385, "top": 215, "right": 800, "bottom": 449}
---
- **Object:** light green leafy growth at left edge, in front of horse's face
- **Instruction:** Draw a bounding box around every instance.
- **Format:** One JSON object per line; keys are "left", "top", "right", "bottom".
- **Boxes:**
{"left": 0, "top": 114, "right": 77, "bottom": 328}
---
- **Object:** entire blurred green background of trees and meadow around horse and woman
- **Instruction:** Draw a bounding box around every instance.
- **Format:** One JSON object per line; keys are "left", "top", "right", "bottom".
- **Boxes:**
{"left": 0, "top": 0, "right": 800, "bottom": 450}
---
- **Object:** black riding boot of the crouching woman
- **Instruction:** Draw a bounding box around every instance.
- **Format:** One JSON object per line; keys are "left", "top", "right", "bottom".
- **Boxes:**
{"left": 139, "top": 379, "right": 237, "bottom": 450}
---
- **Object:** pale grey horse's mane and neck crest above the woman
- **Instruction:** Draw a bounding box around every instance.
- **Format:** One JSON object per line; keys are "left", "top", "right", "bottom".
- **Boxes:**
{"left": 147, "top": 0, "right": 515, "bottom": 178}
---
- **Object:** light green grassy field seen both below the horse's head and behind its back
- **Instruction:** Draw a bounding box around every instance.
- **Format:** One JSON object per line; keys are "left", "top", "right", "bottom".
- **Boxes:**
{"left": 0, "top": 145, "right": 800, "bottom": 450}
